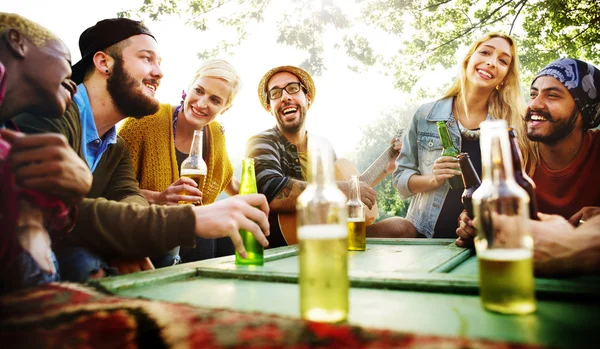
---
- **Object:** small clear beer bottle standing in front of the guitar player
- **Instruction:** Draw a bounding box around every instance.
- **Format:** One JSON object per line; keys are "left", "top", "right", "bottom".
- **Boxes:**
{"left": 346, "top": 175, "right": 367, "bottom": 251}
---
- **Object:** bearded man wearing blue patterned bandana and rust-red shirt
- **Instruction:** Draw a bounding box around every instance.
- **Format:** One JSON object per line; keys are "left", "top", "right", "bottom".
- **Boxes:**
{"left": 525, "top": 58, "right": 600, "bottom": 226}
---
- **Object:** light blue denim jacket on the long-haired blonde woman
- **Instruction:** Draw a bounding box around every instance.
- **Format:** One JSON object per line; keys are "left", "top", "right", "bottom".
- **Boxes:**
{"left": 392, "top": 97, "right": 461, "bottom": 238}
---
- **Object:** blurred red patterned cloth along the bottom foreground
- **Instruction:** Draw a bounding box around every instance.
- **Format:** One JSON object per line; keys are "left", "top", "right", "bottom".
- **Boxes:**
{"left": 0, "top": 283, "right": 539, "bottom": 349}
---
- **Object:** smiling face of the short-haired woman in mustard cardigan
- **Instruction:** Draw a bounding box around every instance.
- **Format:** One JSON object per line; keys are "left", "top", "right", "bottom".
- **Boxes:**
{"left": 183, "top": 76, "right": 232, "bottom": 128}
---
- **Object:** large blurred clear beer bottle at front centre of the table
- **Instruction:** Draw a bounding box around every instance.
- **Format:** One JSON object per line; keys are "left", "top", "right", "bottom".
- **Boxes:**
{"left": 296, "top": 136, "right": 349, "bottom": 323}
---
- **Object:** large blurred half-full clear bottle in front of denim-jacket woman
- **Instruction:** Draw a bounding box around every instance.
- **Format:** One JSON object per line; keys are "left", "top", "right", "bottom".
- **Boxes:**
{"left": 473, "top": 120, "right": 536, "bottom": 314}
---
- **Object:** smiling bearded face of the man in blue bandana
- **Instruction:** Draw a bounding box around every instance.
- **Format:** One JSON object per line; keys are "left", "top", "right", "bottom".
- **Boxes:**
{"left": 525, "top": 76, "right": 583, "bottom": 145}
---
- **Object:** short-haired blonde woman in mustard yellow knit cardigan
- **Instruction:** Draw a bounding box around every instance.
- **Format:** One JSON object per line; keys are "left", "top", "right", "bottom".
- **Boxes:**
{"left": 119, "top": 59, "right": 241, "bottom": 260}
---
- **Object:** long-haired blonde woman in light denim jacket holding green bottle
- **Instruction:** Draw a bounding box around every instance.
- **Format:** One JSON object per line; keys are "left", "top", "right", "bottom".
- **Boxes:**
{"left": 393, "top": 33, "right": 525, "bottom": 239}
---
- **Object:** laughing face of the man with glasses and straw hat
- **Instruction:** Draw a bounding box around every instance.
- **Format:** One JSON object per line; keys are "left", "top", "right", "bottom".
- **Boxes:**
{"left": 267, "top": 72, "right": 310, "bottom": 133}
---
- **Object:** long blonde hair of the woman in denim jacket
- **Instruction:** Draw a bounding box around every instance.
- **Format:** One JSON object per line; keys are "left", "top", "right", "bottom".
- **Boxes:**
{"left": 443, "top": 32, "right": 538, "bottom": 174}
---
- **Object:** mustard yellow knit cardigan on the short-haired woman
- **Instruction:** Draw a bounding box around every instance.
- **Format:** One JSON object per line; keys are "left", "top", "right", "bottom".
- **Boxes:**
{"left": 119, "top": 104, "right": 233, "bottom": 204}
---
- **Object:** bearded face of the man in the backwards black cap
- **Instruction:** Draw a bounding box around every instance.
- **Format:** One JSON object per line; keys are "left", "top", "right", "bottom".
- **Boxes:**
{"left": 106, "top": 34, "right": 163, "bottom": 117}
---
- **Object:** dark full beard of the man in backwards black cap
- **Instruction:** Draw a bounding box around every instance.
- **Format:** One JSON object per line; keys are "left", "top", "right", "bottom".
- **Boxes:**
{"left": 106, "top": 57, "right": 160, "bottom": 119}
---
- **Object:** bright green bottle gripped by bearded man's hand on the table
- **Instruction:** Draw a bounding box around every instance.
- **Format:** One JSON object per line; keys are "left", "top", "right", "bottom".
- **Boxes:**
{"left": 235, "top": 158, "right": 264, "bottom": 265}
